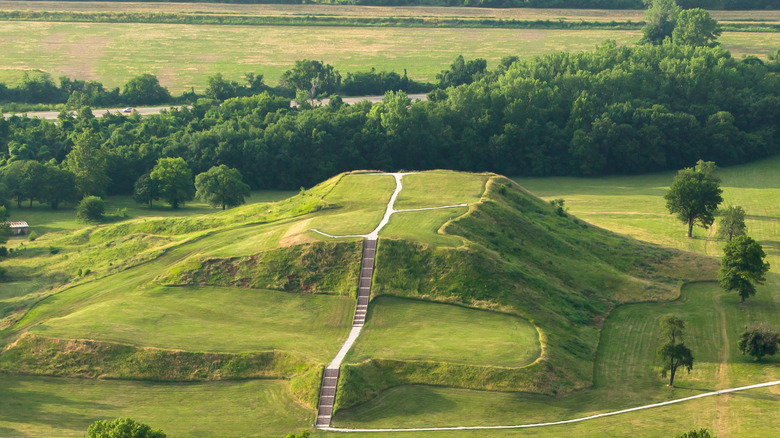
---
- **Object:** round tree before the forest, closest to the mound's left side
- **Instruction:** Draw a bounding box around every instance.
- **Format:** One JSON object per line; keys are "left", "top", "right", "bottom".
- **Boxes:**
{"left": 195, "top": 164, "right": 250, "bottom": 210}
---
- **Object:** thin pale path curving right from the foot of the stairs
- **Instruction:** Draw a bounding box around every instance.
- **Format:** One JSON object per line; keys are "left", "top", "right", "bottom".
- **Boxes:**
{"left": 320, "top": 380, "right": 780, "bottom": 433}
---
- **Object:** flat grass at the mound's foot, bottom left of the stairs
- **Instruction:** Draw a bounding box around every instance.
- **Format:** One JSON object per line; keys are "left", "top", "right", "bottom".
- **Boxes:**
{"left": 0, "top": 375, "right": 314, "bottom": 438}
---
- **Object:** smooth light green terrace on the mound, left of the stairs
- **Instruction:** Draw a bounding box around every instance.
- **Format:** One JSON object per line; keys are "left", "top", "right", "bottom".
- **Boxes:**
{"left": 31, "top": 287, "right": 354, "bottom": 362}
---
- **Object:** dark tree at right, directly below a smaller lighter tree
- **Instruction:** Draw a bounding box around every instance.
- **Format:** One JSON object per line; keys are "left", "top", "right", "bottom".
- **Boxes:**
{"left": 718, "top": 236, "right": 769, "bottom": 303}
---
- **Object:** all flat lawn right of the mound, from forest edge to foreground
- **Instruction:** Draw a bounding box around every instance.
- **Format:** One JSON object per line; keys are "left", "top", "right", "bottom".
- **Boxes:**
{"left": 337, "top": 158, "right": 780, "bottom": 437}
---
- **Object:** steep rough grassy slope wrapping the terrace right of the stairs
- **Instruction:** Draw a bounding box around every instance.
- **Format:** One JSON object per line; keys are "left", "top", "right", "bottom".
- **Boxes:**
{"left": 337, "top": 177, "right": 717, "bottom": 408}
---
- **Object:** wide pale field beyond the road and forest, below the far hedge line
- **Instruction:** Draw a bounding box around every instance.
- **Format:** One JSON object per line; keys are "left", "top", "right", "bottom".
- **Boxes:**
{"left": 0, "top": 22, "right": 780, "bottom": 93}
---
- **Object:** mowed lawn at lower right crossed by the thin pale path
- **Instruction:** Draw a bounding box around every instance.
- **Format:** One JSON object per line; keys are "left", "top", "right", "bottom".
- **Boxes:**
{"left": 335, "top": 283, "right": 780, "bottom": 437}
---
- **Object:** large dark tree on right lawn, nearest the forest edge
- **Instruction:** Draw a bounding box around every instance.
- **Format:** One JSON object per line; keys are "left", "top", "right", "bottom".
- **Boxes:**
{"left": 664, "top": 160, "right": 723, "bottom": 237}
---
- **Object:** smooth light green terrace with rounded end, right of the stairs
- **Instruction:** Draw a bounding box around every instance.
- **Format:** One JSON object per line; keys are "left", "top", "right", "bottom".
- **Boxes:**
{"left": 346, "top": 297, "right": 540, "bottom": 367}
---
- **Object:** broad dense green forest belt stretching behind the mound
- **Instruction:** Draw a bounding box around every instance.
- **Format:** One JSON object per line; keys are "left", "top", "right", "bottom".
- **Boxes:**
{"left": 0, "top": 41, "right": 780, "bottom": 209}
